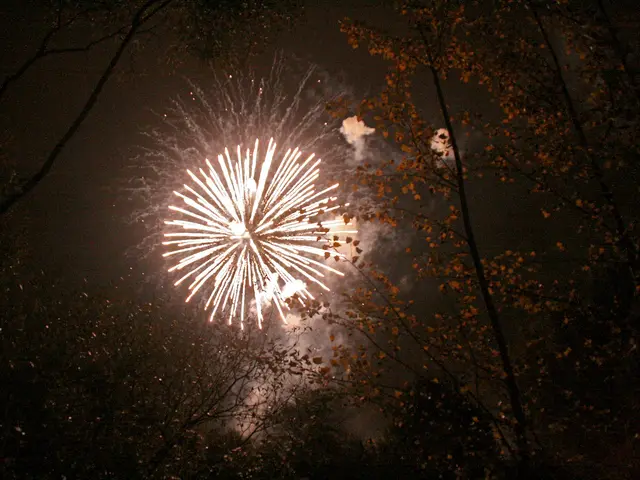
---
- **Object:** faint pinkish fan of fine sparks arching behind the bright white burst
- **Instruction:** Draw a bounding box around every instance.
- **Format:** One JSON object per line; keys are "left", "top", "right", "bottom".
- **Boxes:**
{"left": 129, "top": 54, "right": 352, "bottom": 246}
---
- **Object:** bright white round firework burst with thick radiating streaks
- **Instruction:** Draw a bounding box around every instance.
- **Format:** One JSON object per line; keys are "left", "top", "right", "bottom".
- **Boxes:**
{"left": 163, "top": 139, "right": 356, "bottom": 326}
